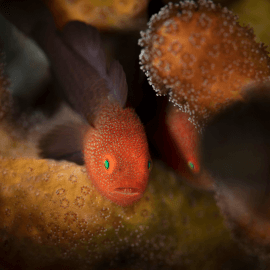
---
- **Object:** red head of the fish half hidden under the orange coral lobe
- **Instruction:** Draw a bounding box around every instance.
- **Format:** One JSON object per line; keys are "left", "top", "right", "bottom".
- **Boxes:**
{"left": 163, "top": 103, "right": 214, "bottom": 190}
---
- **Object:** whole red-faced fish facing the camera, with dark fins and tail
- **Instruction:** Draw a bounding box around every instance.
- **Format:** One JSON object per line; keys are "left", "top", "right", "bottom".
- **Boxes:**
{"left": 1, "top": 1, "right": 151, "bottom": 206}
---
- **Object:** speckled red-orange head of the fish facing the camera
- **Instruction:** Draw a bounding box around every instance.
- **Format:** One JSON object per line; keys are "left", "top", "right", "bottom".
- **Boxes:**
{"left": 84, "top": 102, "right": 150, "bottom": 206}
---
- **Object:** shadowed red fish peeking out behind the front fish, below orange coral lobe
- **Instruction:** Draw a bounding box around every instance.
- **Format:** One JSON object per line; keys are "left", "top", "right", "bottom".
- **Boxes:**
{"left": 147, "top": 98, "right": 214, "bottom": 190}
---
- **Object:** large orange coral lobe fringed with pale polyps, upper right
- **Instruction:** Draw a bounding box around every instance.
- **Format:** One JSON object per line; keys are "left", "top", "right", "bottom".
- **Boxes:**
{"left": 139, "top": 0, "right": 270, "bottom": 127}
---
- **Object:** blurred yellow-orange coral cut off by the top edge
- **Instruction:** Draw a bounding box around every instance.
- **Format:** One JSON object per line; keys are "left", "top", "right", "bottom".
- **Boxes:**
{"left": 43, "top": 0, "right": 149, "bottom": 30}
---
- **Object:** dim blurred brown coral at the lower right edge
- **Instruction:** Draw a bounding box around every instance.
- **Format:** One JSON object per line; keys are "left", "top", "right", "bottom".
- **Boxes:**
{"left": 216, "top": 185, "right": 270, "bottom": 262}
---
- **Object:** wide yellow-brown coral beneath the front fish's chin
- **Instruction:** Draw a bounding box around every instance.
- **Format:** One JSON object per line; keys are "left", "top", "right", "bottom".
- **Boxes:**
{"left": 0, "top": 154, "right": 254, "bottom": 269}
